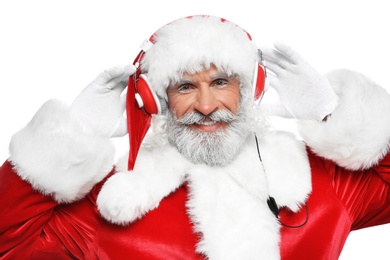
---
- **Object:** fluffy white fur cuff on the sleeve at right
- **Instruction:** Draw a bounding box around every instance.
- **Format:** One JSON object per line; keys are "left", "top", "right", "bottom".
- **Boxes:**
{"left": 298, "top": 70, "right": 390, "bottom": 170}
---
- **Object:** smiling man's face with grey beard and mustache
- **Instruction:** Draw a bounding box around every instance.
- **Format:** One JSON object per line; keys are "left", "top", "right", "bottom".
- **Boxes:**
{"left": 167, "top": 66, "right": 248, "bottom": 166}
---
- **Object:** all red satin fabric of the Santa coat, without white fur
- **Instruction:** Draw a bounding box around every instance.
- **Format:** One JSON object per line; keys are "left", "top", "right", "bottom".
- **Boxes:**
{"left": 0, "top": 150, "right": 390, "bottom": 259}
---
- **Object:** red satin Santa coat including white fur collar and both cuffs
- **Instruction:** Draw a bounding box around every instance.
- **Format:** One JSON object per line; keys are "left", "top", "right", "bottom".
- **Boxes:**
{"left": 0, "top": 68, "right": 390, "bottom": 259}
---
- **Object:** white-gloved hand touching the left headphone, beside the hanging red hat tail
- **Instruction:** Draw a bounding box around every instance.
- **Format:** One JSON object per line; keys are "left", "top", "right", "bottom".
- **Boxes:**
{"left": 70, "top": 65, "right": 136, "bottom": 137}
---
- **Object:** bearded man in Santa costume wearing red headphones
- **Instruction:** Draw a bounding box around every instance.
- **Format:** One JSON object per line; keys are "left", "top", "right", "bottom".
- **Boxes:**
{"left": 0, "top": 16, "right": 390, "bottom": 260}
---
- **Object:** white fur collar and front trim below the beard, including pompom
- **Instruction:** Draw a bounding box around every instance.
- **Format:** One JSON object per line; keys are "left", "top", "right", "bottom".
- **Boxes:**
{"left": 97, "top": 132, "right": 311, "bottom": 259}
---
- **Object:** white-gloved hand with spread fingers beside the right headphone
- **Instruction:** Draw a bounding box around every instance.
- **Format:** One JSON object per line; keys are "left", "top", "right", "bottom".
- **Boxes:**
{"left": 261, "top": 43, "right": 338, "bottom": 121}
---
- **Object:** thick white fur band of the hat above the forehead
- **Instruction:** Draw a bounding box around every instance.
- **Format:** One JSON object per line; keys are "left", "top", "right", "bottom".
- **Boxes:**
{"left": 141, "top": 16, "right": 259, "bottom": 98}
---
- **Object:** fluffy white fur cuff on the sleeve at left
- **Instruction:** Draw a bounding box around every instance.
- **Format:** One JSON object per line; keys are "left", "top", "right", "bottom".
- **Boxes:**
{"left": 9, "top": 100, "right": 115, "bottom": 202}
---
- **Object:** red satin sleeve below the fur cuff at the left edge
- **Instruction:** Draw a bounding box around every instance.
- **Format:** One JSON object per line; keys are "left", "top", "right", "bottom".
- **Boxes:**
{"left": 0, "top": 161, "right": 57, "bottom": 259}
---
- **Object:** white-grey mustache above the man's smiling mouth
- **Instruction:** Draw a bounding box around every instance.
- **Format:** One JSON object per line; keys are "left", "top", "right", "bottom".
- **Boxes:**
{"left": 176, "top": 110, "right": 237, "bottom": 125}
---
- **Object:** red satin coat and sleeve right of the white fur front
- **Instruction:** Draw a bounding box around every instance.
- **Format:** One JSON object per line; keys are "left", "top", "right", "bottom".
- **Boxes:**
{"left": 279, "top": 150, "right": 390, "bottom": 260}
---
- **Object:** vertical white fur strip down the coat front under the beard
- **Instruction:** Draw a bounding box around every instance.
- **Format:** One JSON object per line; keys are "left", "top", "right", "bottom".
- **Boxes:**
{"left": 187, "top": 136, "right": 280, "bottom": 260}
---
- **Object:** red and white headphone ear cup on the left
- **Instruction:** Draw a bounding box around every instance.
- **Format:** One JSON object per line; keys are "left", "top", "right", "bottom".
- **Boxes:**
{"left": 135, "top": 74, "right": 161, "bottom": 115}
